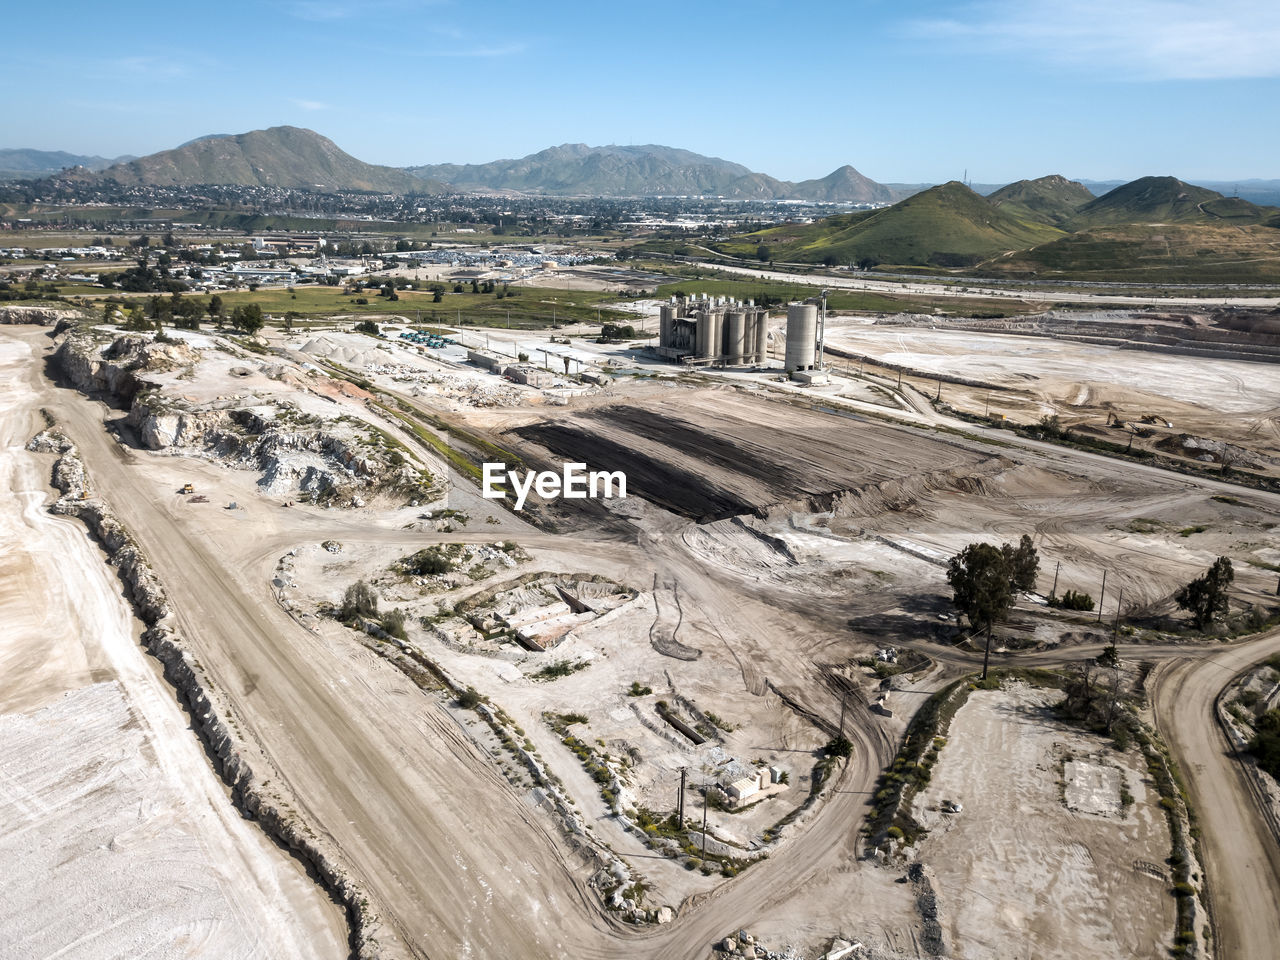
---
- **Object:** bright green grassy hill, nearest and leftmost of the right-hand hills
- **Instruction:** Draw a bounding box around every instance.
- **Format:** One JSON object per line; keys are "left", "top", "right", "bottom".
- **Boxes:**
{"left": 717, "top": 180, "right": 1062, "bottom": 268}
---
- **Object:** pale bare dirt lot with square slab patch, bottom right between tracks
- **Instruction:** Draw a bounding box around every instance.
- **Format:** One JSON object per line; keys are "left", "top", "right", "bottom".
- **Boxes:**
{"left": 913, "top": 684, "right": 1175, "bottom": 960}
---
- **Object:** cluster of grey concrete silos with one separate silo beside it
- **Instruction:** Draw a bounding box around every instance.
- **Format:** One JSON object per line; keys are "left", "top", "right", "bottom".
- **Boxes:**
{"left": 654, "top": 294, "right": 827, "bottom": 383}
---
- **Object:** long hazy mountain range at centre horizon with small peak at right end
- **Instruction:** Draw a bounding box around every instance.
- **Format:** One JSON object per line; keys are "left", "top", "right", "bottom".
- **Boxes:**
{"left": 407, "top": 143, "right": 892, "bottom": 202}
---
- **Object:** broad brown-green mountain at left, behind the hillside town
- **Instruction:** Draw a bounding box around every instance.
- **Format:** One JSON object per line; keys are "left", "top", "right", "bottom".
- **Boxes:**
{"left": 80, "top": 127, "right": 430, "bottom": 193}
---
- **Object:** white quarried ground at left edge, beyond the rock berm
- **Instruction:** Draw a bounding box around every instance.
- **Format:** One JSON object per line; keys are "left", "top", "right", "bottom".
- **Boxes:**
{"left": 0, "top": 340, "right": 347, "bottom": 960}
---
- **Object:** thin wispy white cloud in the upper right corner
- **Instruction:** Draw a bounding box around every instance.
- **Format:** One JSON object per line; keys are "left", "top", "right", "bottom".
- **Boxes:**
{"left": 911, "top": 0, "right": 1280, "bottom": 81}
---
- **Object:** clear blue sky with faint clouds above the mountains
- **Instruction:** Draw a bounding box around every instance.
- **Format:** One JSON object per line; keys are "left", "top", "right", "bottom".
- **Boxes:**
{"left": 0, "top": 0, "right": 1280, "bottom": 183}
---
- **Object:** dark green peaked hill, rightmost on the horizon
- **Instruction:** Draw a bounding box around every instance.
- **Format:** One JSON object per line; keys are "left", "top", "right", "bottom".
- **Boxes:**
{"left": 1073, "top": 177, "right": 1275, "bottom": 227}
